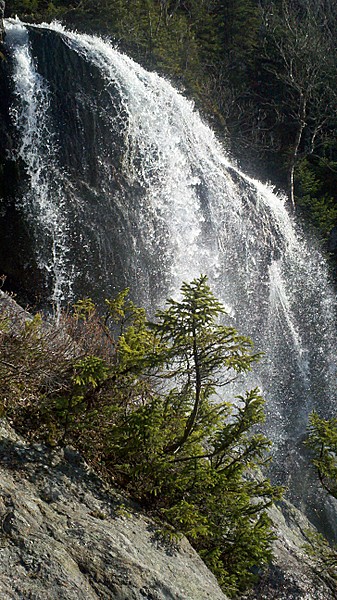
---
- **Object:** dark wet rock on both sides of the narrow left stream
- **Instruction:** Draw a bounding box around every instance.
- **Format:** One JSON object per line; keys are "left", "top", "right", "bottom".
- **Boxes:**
{"left": 0, "top": 28, "right": 166, "bottom": 308}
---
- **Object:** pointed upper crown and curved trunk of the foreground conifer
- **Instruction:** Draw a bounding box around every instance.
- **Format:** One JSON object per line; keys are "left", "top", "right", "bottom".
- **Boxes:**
{"left": 151, "top": 276, "right": 258, "bottom": 449}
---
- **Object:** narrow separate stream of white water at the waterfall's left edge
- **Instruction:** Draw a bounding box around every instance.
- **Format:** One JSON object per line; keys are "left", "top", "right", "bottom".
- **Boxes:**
{"left": 7, "top": 23, "right": 71, "bottom": 308}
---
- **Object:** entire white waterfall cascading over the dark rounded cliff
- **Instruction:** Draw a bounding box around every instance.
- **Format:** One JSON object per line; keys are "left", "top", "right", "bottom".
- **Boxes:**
{"left": 2, "top": 21, "right": 336, "bottom": 528}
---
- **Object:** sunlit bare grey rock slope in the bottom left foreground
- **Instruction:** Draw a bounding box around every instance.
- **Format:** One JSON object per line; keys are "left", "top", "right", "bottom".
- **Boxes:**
{"left": 0, "top": 425, "right": 226, "bottom": 600}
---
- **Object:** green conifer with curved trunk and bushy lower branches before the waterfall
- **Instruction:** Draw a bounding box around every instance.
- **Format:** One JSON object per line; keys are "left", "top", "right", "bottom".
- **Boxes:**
{"left": 102, "top": 276, "right": 281, "bottom": 594}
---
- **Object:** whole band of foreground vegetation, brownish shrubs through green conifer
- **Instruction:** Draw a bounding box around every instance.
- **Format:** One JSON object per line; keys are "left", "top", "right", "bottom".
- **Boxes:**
{"left": 0, "top": 276, "right": 281, "bottom": 594}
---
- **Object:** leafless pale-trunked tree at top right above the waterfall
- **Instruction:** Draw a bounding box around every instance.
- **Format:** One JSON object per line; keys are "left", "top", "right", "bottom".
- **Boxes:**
{"left": 263, "top": 0, "right": 337, "bottom": 207}
